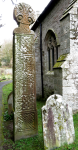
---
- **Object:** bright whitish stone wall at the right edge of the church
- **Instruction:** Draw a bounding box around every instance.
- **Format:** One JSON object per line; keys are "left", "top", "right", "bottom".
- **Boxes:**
{"left": 63, "top": 1, "right": 78, "bottom": 113}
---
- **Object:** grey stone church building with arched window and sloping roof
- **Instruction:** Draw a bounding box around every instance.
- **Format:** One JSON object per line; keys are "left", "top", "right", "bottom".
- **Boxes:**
{"left": 31, "top": 0, "right": 78, "bottom": 113}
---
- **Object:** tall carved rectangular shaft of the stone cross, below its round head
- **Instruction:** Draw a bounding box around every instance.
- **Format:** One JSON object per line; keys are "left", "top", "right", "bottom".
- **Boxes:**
{"left": 14, "top": 34, "right": 37, "bottom": 140}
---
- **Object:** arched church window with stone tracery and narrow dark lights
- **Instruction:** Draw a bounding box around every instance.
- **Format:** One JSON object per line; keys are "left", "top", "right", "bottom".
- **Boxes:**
{"left": 46, "top": 30, "right": 58, "bottom": 71}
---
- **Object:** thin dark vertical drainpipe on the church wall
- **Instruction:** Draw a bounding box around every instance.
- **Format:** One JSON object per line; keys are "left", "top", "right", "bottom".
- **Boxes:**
{"left": 40, "top": 23, "right": 44, "bottom": 98}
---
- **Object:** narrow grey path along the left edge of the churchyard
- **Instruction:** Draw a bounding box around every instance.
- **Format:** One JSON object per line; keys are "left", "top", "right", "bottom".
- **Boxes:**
{"left": 0, "top": 80, "right": 12, "bottom": 150}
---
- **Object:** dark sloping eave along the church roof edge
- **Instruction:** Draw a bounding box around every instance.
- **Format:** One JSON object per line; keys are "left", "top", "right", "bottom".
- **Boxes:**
{"left": 31, "top": 0, "right": 59, "bottom": 31}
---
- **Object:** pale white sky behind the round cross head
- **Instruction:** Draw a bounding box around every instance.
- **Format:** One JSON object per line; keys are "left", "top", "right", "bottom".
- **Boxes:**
{"left": 0, "top": 0, "right": 50, "bottom": 45}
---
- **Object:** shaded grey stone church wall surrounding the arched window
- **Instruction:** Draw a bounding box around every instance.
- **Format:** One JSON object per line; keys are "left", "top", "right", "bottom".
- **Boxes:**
{"left": 35, "top": 0, "right": 72, "bottom": 95}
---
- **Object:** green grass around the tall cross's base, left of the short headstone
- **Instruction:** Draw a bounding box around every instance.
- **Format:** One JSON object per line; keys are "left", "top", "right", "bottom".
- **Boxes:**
{"left": 3, "top": 83, "right": 45, "bottom": 150}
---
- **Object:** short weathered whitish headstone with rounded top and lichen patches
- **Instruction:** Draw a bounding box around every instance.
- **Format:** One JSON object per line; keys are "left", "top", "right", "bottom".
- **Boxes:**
{"left": 42, "top": 94, "right": 75, "bottom": 150}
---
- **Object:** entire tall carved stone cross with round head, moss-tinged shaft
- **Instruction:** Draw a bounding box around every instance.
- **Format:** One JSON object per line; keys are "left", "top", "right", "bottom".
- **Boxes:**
{"left": 13, "top": 3, "right": 38, "bottom": 140}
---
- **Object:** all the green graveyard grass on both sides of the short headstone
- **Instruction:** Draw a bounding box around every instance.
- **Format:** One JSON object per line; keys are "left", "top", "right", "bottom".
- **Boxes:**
{"left": 3, "top": 83, "right": 78, "bottom": 150}
